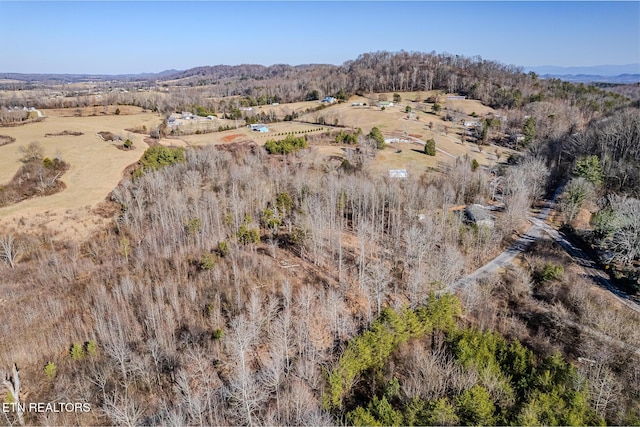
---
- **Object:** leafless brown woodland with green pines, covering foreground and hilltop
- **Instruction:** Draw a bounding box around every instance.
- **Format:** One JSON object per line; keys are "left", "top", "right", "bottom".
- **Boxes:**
{"left": 0, "top": 52, "right": 640, "bottom": 425}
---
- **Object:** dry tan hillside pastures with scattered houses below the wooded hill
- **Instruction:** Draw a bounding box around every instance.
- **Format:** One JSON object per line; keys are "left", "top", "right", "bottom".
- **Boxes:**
{"left": 174, "top": 92, "right": 513, "bottom": 182}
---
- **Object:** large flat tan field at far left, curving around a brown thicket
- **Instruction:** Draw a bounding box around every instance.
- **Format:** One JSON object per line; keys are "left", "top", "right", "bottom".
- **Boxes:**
{"left": 0, "top": 110, "right": 161, "bottom": 239}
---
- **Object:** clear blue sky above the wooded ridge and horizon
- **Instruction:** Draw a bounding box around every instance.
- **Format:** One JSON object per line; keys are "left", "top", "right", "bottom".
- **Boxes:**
{"left": 0, "top": 0, "right": 640, "bottom": 74}
